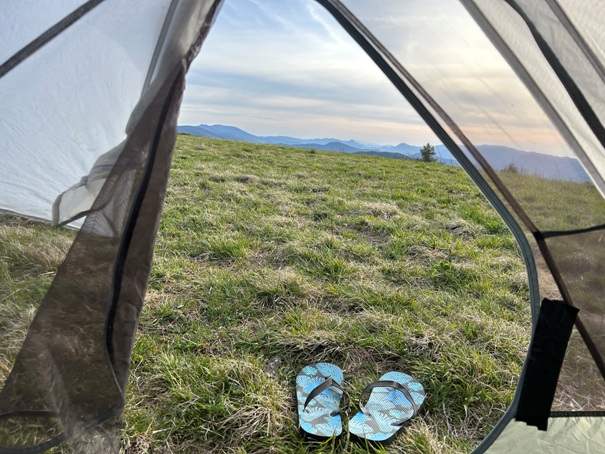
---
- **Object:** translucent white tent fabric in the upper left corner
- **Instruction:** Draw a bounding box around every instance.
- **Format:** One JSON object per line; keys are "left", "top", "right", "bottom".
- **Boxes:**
{"left": 0, "top": 0, "right": 217, "bottom": 227}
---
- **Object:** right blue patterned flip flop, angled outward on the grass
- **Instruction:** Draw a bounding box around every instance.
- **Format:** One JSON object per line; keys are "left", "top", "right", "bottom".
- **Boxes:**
{"left": 349, "top": 372, "right": 425, "bottom": 444}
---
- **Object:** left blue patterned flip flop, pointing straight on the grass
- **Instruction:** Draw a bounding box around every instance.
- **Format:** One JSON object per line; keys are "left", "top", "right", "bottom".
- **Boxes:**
{"left": 296, "top": 363, "right": 344, "bottom": 438}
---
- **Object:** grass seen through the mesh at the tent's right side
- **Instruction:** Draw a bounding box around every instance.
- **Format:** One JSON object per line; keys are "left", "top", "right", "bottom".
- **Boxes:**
{"left": 501, "top": 172, "right": 605, "bottom": 411}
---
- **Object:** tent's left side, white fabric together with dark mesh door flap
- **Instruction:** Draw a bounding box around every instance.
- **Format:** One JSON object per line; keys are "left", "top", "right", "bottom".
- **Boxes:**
{"left": 0, "top": 0, "right": 221, "bottom": 453}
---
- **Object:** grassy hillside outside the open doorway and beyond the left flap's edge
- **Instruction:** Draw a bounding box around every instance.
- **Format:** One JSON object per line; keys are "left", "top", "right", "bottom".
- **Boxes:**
{"left": 0, "top": 135, "right": 530, "bottom": 453}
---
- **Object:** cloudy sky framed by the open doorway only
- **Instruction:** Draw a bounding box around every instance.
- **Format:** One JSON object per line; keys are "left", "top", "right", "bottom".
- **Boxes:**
{"left": 179, "top": 0, "right": 434, "bottom": 143}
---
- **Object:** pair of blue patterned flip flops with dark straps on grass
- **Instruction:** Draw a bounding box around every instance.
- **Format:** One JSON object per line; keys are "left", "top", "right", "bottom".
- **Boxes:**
{"left": 296, "top": 363, "right": 425, "bottom": 443}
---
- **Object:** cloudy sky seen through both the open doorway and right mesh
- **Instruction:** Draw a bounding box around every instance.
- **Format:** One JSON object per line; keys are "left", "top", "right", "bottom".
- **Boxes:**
{"left": 179, "top": 0, "right": 566, "bottom": 155}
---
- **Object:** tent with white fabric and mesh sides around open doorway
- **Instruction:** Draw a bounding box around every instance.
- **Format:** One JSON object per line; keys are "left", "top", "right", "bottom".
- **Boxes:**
{"left": 0, "top": 0, "right": 605, "bottom": 453}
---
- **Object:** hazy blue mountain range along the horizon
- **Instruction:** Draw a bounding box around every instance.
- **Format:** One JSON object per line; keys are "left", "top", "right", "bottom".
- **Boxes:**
{"left": 178, "top": 124, "right": 590, "bottom": 182}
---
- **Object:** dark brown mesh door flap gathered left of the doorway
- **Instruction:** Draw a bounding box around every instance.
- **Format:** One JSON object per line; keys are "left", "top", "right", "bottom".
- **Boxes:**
{"left": 0, "top": 63, "right": 184, "bottom": 449}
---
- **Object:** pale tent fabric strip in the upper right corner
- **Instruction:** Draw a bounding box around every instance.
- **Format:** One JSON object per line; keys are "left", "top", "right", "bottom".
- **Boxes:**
{"left": 462, "top": 0, "right": 605, "bottom": 200}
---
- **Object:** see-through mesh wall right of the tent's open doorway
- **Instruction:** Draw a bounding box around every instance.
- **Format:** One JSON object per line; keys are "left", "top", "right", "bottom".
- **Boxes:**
{"left": 330, "top": 0, "right": 605, "bottom": 414}
